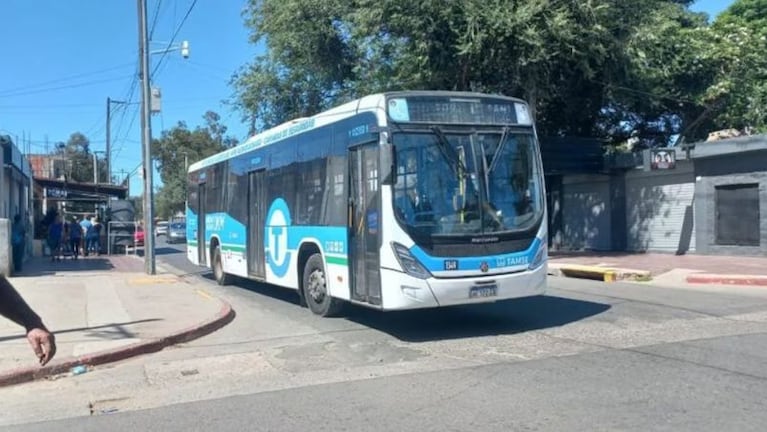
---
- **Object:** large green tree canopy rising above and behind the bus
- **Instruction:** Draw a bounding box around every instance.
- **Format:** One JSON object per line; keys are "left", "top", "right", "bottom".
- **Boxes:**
{"left": 233, "top": 0, "right": 767, "bottom": 144}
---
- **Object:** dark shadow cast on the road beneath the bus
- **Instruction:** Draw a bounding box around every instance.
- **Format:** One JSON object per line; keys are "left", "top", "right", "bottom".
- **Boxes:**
{"left": 224, "top": 273, "right": 610, "bottom": 342}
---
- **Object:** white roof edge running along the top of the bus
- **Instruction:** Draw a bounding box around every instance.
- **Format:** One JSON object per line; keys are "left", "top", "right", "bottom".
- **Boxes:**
{"left": 188, "top": 90, "right": 525, "bottom": 172}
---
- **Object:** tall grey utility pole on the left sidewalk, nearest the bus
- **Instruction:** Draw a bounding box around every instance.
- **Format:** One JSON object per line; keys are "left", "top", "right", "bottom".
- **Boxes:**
{"left": 137, "top": 0, "right": 156, "bottom": 275}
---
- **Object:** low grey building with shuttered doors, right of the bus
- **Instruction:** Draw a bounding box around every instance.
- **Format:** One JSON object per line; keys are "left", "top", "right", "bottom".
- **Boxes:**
{"left": 547, "top": 135, "right": 767, "bottom": 256}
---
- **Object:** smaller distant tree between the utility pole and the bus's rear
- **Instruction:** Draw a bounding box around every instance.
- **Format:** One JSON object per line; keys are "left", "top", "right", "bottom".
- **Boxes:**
{"left": 152, "top": 111, "right": 237, "bottom": 218}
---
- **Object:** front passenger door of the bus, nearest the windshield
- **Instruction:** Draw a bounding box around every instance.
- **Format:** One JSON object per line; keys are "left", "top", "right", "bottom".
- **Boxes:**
{"left": 348, "top": 143, "right": 381, "bottom": 305}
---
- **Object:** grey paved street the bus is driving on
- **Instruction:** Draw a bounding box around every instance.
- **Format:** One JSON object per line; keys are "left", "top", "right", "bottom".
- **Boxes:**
{"left": 0, "top": 240, "right": 767, "bottom": 431}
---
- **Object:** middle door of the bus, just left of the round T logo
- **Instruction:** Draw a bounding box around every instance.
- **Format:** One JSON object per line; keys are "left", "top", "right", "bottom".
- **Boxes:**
{"left": 247, "top": 170, "right": 266, "bottom": 278}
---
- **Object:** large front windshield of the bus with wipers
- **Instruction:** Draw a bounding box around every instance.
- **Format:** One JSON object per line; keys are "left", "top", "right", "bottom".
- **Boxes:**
{"left": 392, "top": 128, "right": 543, "bottom": 236}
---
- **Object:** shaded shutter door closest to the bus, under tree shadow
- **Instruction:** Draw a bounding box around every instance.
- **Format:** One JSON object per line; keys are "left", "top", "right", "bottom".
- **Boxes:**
{"left": 562, "top": 177, "right": 611, "bottom": 250}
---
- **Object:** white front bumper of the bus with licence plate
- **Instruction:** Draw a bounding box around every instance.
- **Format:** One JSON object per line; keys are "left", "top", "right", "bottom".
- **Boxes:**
{"left": 381, "top": 263, "right": 547, "bottom": 310}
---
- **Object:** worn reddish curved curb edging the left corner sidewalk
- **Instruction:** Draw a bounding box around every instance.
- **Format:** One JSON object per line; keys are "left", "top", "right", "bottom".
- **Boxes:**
{"left": 0, "top": 299, "right": 236, "bottom": 387}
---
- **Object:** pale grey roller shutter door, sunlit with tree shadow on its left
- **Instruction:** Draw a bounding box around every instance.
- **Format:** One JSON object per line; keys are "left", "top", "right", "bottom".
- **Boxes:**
{"left": 626, "top": 172, "right": 695, "bottom": 253}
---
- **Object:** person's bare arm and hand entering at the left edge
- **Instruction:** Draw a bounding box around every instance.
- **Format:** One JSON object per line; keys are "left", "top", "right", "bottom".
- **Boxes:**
{"left": 0, "top": 276, "right": 56, "bottom": 366}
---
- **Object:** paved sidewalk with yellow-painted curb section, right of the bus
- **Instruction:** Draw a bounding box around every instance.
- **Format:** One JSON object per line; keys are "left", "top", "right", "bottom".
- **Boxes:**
{"left": 549, "top": 252, "right": 767, "bottom": 287}
